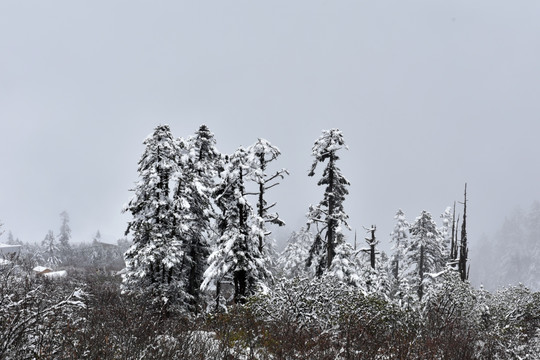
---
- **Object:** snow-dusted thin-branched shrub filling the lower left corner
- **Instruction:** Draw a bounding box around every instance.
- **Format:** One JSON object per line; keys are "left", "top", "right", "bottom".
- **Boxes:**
{"left": 0, "top": 265, "right": 86, "bottom": 360}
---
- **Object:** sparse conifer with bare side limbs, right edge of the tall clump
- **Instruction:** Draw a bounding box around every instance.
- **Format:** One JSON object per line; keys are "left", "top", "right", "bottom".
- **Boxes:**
{"left": 247, "top": 139, "right": 288, "bottom": 254}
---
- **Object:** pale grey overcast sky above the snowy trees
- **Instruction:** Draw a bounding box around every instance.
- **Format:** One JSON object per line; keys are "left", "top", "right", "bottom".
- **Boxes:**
{"left": 0, "top": 0, "right": 540, "bottom": 272}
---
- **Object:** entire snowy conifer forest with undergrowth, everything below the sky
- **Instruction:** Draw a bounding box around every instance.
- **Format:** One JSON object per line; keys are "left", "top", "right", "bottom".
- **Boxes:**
{"left": 0, "top": 125, "right": 540, "bottom": 360}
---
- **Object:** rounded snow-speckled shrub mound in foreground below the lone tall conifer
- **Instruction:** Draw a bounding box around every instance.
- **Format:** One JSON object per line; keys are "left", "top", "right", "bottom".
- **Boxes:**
{"left": 248, "top": 276, "right": 418, "bottom": 359}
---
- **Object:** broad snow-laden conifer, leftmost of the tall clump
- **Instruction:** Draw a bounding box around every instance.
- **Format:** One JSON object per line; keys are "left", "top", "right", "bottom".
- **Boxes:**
{"left": 122, "top": 125, "right": 187, "bottom": 310}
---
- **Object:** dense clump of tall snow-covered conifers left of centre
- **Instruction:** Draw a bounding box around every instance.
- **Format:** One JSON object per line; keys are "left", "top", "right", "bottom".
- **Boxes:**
{"left": 123, "top": 125, "right": 287, "bottom": 311}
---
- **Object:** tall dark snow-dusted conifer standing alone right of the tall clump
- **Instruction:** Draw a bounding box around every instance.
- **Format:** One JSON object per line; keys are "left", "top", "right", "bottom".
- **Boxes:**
{"left": 307, "top": 129, "right": 350, "bottom": 276}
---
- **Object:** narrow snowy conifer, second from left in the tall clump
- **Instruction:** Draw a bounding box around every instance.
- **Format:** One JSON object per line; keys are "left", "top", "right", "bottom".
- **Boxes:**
{"left": 173, "top": 125, "right": 220, "bottom": 310}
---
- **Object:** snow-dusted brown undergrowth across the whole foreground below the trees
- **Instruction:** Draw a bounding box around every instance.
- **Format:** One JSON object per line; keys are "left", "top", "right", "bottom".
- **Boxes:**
{"left": 0, "top": 258, "right": 540, "bottom": 359}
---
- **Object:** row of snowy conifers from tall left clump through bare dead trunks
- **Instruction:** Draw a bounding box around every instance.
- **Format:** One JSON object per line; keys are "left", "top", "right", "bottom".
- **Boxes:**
{"left": 123, "top": 125, "right": 476, "bottom": 312}
